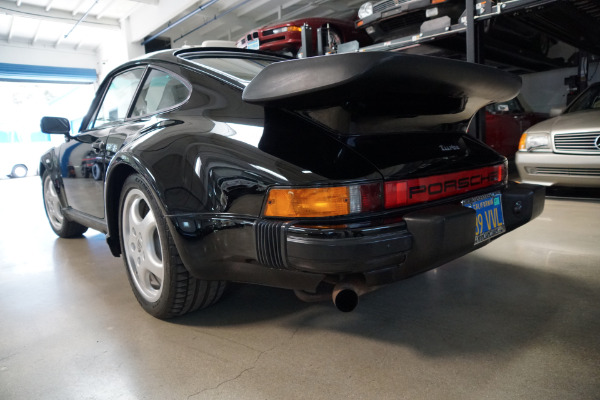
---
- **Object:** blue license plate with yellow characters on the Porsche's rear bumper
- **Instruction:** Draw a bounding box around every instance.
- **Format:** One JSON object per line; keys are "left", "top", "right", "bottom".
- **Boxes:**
{"left": 462, "top": 192, "right": 506, "bottom": 244}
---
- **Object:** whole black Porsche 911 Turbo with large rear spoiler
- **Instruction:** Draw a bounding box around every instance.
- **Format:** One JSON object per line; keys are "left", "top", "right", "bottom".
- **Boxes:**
{"left": 40, "top": 48, "right": 544, "bottom": 318}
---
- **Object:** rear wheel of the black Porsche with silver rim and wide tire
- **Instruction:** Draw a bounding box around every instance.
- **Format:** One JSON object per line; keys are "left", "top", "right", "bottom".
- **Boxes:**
{"left": 119, "top": 174, "right": 226, "bottom": 319}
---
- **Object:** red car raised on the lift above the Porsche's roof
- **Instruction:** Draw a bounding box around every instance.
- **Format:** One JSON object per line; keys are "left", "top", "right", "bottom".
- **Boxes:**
{"left": 237, "top": 18, "right": 371, "bottom": 56}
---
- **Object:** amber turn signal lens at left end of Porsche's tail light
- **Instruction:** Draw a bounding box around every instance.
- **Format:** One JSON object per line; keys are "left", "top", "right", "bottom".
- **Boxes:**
{"left": 265, "top": 187, "right": 350, "bottom": 218}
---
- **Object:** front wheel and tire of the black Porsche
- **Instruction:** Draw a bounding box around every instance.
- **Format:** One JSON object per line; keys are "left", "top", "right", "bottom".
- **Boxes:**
{"left": 42, "top": 171, "right": 88, "bottom": 238}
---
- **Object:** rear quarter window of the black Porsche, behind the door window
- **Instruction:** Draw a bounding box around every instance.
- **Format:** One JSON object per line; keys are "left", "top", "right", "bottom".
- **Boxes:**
{"left": 131, "top": 69, "right": 190, "bottom": 117}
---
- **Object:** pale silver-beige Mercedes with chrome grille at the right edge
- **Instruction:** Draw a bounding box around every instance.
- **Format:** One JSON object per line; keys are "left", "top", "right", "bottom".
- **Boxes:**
{"left": 515, "top": 83, "right": 600, "bottom": 187}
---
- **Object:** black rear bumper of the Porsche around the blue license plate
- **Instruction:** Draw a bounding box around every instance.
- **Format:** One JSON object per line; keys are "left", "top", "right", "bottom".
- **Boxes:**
{"left": 282, "top": 183, "right": 545, "bottom": 283}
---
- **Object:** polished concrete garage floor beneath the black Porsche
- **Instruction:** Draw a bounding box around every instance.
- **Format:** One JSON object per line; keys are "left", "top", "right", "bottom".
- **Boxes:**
{"left": 0, "top": 177, "right": 600, "bottom": 400}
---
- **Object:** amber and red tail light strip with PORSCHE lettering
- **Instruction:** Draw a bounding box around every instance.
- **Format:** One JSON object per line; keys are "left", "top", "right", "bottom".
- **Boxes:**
{"left": 264, "top": 164, "right": 507, "bottom": 218}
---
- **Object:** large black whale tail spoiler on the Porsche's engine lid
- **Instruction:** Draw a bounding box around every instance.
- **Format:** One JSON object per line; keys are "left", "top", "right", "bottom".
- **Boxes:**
{"left": 242, "top": 52, "right": 521, "bottom": 130}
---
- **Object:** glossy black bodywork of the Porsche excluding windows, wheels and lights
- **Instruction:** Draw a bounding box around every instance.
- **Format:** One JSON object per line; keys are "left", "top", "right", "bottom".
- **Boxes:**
{"left": 40, "top": 49, "right": 543, "bottom": 314}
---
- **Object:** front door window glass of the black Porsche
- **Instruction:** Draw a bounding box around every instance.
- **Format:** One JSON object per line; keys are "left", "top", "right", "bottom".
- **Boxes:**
{"left": 92, "top": 68, "right": 144, "bottom": 128}
